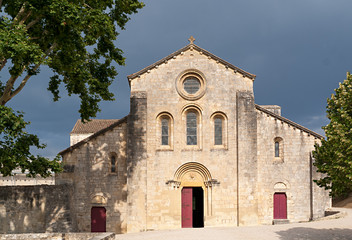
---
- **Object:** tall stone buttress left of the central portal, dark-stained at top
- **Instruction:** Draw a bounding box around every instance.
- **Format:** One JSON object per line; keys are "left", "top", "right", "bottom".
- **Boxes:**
{"left": 127, "top": 91, "right": 147, "bottom": 232}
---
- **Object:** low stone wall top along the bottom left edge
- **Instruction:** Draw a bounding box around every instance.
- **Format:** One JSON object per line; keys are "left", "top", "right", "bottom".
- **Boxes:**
{"left": 0, "top": 233, "right": 115, "bottom": 240}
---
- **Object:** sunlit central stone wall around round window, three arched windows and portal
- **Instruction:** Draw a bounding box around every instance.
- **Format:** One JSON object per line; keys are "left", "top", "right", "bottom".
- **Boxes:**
{"left": 128, "top": 49, "right": 256, "bottom": 231}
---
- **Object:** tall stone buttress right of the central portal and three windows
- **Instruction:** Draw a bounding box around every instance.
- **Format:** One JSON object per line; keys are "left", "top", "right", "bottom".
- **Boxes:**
{"left": 236, "top": 91, "right": 258, "bottom": 226}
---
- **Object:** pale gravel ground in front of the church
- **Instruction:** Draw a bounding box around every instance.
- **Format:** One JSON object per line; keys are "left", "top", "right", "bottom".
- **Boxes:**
{"left": 116, "top": 208, "right": 352, "bottom": 240}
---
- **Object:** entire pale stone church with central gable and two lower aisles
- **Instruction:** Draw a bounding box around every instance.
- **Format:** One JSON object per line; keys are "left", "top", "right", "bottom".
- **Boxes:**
{"left": 56, "top": 38, "right": 330, "bottom": 233}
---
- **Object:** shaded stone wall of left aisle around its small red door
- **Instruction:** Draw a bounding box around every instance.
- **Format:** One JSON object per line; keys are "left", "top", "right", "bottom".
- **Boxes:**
{"left": 56, "top": 121, "right": 127, "bottom": 233}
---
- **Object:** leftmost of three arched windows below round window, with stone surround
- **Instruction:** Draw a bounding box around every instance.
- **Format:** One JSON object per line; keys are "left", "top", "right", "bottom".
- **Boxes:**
{"left": 155, "top": 112, "right": 174, "bottom": 150}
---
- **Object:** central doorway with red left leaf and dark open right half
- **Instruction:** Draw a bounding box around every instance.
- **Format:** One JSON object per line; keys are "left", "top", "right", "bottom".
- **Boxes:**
{"left": 181, "top": 187, "right": 204, "bottom": 228}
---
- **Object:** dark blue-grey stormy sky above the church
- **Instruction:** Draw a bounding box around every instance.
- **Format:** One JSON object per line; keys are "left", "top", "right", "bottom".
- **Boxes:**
{"left": 4, "top": 0, "right": 352, "bottom": 157}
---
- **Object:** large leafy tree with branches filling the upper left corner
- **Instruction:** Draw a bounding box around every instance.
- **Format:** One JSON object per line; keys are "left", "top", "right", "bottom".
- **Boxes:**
{"left": 0, "top": 0, "right": 144, "bottom": 175}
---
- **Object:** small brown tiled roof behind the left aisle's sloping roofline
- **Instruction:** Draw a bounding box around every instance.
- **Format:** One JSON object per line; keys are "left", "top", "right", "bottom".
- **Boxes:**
{"left": 71, "top": 119, "right": 118, "bottom": 134}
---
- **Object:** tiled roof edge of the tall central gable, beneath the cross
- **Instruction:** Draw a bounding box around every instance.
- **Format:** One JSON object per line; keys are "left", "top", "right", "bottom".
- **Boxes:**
{"left": 127, "top": 43, "right": 256, "bottom": 81}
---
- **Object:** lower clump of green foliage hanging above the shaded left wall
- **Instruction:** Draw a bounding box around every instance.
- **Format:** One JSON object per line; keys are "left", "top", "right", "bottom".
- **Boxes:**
{"left": 0, "top": 105, "right": 61, "bottom": 177}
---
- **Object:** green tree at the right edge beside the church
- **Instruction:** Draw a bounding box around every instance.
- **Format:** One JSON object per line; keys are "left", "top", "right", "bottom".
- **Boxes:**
{"left": 313, "top": 73, "right": 352, "bottom": 196}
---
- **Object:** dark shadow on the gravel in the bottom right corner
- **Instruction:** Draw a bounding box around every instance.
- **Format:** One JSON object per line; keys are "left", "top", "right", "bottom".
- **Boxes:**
{"left": 276, "top": 226, "right": 352, "bottom": 240}
